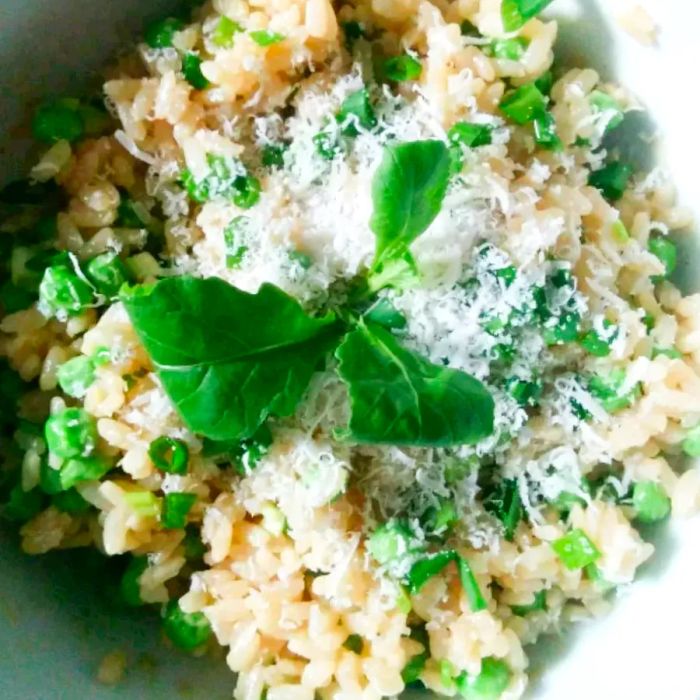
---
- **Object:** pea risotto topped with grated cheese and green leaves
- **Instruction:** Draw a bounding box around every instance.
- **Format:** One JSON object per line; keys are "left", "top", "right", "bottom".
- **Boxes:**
{"left": 0, "top": 0, "right": 700, "bottom": 700}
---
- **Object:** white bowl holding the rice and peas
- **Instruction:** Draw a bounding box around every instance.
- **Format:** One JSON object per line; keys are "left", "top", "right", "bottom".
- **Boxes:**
{"left": 0, "top": 0, "right": 700, "bottom": 700}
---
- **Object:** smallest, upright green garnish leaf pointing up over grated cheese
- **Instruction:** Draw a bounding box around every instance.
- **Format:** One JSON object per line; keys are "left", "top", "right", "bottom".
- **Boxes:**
{"left": 369, "top": 141, "right": 450, "bottom": 282}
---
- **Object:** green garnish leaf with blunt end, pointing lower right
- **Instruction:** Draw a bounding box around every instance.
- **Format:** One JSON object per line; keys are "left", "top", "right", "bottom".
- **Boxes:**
{"left": 336, "top": 321, "right": 494, "bottom": 447}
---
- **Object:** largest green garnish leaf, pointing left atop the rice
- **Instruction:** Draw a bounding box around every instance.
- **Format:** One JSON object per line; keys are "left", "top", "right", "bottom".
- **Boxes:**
{"left": 122, "top": 277, "right": 337, "bottom": 440}
